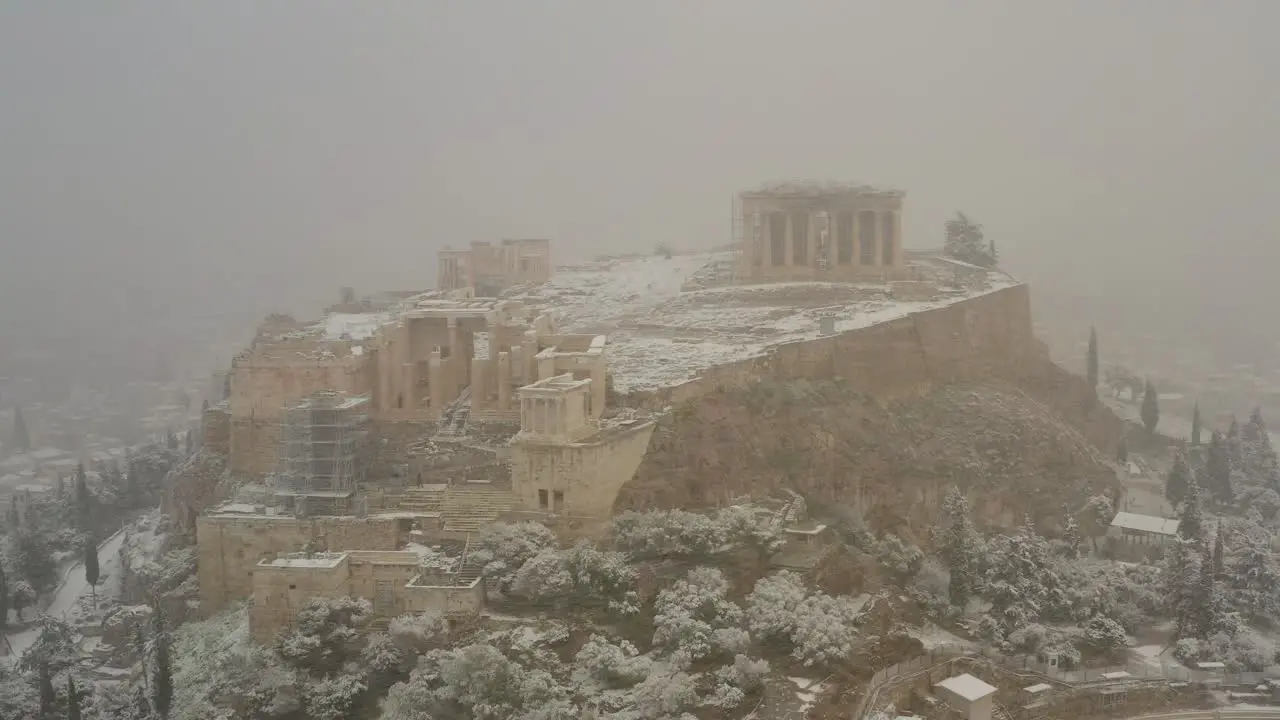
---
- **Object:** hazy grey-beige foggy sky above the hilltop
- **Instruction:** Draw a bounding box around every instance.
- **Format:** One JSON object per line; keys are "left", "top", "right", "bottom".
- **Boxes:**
{"left": 0, "top": 0, "right": 1280, "bottom": 392}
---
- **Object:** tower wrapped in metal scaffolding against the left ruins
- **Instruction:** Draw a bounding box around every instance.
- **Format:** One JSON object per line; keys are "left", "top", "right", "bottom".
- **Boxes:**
{"left": 274, "top": 391, "right": 369, "bottom": 512}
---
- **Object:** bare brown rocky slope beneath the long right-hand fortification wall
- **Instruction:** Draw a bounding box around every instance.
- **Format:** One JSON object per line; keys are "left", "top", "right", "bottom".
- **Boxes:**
{"left": 616, "top": 361, "right": 1123, "bottom": 541}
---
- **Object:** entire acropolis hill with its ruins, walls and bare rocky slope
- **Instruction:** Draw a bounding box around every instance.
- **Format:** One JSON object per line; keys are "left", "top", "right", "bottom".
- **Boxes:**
{"left": 168, "top": 184, "right": 1114, "bottom": 637}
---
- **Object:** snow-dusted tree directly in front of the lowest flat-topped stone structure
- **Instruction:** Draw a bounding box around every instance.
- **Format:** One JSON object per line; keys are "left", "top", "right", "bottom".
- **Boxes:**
{"left": 275, "top": 597, "right": 372, "bottom": 675}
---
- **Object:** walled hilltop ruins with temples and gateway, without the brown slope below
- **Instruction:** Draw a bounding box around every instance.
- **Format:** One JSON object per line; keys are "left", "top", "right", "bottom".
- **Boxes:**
{"left": 186, "top": 184, "right": 1043, "bottom": 638}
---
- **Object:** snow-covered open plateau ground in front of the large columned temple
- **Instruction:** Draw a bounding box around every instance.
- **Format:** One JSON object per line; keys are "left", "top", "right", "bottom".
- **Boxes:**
{"left": 508, "top": 252, "right": 1018, "bottom": 393}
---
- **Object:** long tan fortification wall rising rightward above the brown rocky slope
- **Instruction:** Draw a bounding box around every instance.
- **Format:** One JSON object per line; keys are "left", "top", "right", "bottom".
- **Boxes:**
{"left": 618, "top": 284, "right": 1047, "bottom": 410}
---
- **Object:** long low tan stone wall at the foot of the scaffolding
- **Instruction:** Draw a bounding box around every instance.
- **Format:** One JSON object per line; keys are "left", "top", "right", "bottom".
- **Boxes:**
{"left": 196, "top": 515, "right": 404, "bottom": 618}
